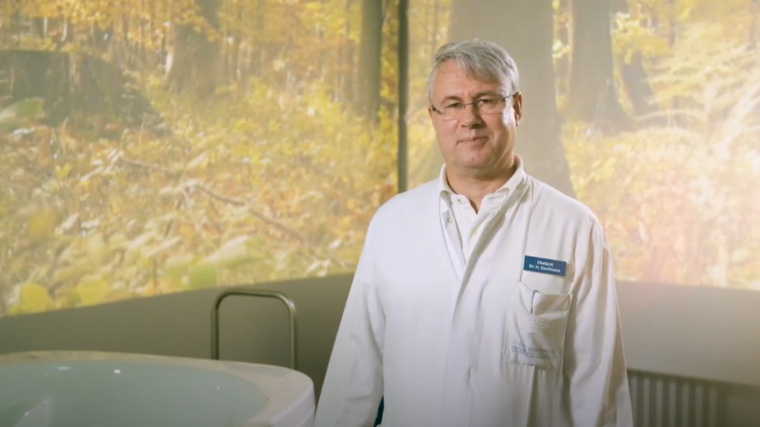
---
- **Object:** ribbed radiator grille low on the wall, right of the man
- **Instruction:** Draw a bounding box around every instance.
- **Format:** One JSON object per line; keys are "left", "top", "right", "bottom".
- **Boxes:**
{"left": 628, "top": 371, "right": 726, "bottom": 427}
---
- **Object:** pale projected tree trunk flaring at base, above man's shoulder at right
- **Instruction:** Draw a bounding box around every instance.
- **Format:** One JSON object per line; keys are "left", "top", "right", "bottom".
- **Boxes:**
{"left": 562, "top": 0, "right": 632, "bottom": 132}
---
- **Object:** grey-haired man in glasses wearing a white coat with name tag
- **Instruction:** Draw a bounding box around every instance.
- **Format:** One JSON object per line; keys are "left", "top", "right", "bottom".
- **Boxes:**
{"left": 316, "top": 41, "right": 633, "bottom": 427}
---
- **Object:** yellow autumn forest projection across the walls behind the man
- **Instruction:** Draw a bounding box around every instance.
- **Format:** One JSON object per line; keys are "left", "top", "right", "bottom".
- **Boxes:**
{"left": 0, "top": 0, "right": 760, "bottom": 316}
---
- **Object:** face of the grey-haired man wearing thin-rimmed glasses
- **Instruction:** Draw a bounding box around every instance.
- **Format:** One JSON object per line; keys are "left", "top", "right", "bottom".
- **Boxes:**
{"left": 428, "top": 61, "right": 522, "bottom": 176}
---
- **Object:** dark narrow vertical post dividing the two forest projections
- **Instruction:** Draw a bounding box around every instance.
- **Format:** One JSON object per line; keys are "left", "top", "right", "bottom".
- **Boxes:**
{"left": 397, "top": 0, "right": 409, "bottom": 193}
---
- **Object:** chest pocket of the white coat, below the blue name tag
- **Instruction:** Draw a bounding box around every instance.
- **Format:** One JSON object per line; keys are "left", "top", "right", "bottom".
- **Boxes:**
{"left": 504, "top": 281, "right": 573, "bottom": 370}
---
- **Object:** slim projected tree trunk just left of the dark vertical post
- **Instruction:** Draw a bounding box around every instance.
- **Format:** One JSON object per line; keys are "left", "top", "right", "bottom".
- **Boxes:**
{"left": 357, "top": 0, "right": 383, "bottom": 122}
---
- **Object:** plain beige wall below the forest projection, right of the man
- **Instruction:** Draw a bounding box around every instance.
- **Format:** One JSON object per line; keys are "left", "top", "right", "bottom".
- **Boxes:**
{"left": 618, "top": 283, "right": 760, "bottom": 390}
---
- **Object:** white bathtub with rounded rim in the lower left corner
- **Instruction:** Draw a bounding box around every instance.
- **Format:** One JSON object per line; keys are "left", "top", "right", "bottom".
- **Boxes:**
{"left": 0, "top": 351, "right": 315, "bottom": 427}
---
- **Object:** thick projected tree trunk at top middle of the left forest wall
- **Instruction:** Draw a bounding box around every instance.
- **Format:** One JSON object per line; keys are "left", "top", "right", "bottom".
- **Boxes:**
{"left": 167, "top": 0, "right": 221, "bottom": 99}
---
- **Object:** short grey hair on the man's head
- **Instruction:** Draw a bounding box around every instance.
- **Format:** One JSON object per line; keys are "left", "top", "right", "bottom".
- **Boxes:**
{"left": 428, "top": 39, "right": 520, "bottom": 100}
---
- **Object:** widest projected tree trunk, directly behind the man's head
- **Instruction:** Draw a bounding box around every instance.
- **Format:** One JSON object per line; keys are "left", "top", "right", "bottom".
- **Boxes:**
{"left": 428, "top": 0, "right": 575, "bottom": 197}
